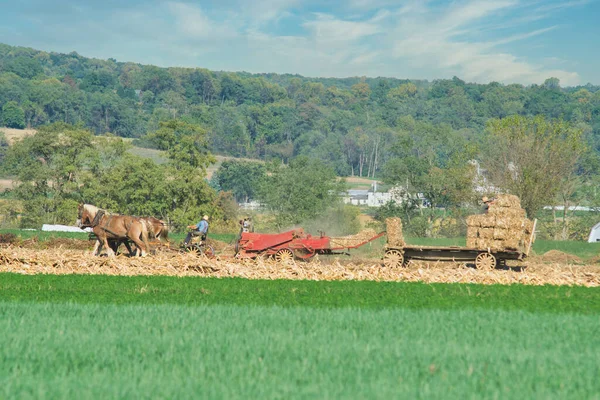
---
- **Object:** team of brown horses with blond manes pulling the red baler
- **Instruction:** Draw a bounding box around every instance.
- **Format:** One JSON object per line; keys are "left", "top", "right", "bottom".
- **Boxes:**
{"left": 77, "top": 204, "right": 168, "bottom": 257}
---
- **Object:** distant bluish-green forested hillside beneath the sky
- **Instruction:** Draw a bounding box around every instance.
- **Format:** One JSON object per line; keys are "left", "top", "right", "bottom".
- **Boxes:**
{"left": 0, "top": 44, "right": 600, "bottom": 177}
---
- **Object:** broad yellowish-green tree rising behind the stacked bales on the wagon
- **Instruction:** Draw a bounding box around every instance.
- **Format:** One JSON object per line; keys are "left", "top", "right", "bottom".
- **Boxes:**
{"left": 482, "top": 116, "right": 586, "bottom": 218}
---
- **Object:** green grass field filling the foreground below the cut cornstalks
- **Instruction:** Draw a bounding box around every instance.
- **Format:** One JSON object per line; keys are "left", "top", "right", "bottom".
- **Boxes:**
{"left": 0, "top": 274, "right": 600, "bottom": 399}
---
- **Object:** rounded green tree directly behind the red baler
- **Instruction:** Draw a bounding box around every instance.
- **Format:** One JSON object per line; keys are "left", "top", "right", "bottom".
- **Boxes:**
{"left": 260, "top": 157, "right": 345, "bottom": 229}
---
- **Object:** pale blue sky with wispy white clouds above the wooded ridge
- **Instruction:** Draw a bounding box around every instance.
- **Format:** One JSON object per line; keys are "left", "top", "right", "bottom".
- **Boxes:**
{"left": 0, "top": 0, "right": 600, "bottom": 86}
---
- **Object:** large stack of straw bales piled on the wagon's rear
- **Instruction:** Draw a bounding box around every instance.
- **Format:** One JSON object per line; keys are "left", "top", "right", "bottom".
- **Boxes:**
{"left": 467, "top": 194, "right": 533, "bottom": 251}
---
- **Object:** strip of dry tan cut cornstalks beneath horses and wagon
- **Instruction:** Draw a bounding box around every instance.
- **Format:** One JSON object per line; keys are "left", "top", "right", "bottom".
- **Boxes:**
{"left": 0, "top": 246, "right": 600, "bottom": 286}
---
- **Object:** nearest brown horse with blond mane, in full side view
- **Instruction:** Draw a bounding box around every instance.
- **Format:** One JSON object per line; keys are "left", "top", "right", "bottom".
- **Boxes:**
{"left": 77, "top": 204, "right": 150, "bottom": 257}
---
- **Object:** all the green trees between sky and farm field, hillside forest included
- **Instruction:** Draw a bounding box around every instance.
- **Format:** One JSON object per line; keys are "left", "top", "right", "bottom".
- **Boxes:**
{"left": 0, "top": 44, "right": 600, "bottom": 238}
